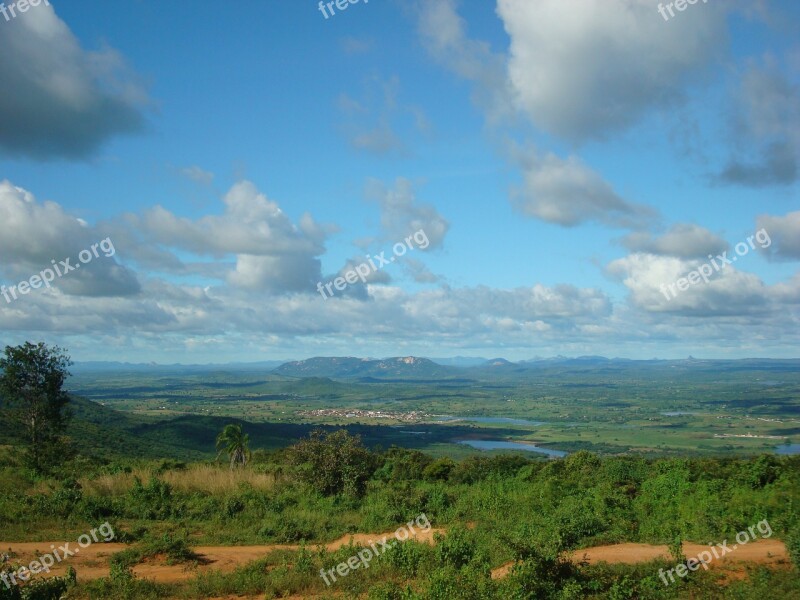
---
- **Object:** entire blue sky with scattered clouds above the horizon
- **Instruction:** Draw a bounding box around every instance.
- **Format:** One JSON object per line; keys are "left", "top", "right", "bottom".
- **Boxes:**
{"left": 0, "top": 0, "right": 800, "bottom": 363}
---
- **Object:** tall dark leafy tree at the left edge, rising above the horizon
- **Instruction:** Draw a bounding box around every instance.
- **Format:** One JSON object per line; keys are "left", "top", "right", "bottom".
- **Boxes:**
{"left": 0, "top": 342, "right": 72, "bottom": 471}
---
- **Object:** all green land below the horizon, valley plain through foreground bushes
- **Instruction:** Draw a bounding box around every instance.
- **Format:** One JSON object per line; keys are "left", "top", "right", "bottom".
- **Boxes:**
{"left": 0, "top": 354, "right": 800, "bottom": 600}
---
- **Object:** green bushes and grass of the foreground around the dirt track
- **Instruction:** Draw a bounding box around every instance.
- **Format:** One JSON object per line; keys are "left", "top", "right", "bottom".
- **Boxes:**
{"left": 0, "top": 432, "right": 800, "bottom": 599}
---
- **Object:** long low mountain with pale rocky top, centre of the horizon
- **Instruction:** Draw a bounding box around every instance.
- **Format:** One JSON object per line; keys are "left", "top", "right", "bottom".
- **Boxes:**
{"left": 273, "top": 356, "right": 463, "bottom": 379}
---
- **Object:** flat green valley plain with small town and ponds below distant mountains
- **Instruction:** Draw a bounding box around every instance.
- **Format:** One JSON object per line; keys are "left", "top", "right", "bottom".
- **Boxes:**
{"left": 69, "top": 363, "right": 800, "bottom": 456}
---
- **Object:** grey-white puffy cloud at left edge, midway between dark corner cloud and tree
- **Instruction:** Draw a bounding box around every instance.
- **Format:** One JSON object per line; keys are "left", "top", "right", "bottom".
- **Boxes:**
{"left": 0, "top": 180, "right": 140, "bottom": 296}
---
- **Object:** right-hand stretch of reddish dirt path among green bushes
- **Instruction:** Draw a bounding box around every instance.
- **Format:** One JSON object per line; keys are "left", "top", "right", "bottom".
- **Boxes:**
{"left": 492, "top": 539, "right": 789, "bottom": 579}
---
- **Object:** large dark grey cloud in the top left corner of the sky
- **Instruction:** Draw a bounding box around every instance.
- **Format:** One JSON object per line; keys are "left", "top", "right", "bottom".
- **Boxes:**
{"left": 0, "top": 4, "right": 149, "bottom": 160}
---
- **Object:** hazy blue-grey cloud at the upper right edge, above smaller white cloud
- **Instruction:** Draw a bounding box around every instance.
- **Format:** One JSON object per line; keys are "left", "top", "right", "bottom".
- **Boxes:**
{"left": 719, "top": 57, "right": 800, "bottom": 187}
